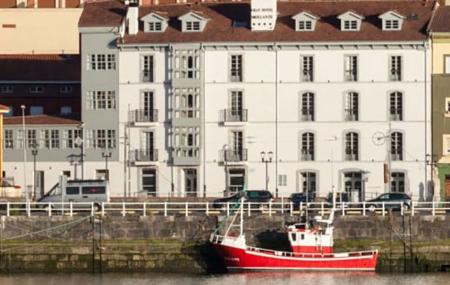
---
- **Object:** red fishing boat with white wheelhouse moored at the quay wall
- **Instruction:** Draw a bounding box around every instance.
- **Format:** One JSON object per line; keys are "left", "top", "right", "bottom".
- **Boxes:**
{"left": 210, "top": 200, "right": 378, "bottom": 271}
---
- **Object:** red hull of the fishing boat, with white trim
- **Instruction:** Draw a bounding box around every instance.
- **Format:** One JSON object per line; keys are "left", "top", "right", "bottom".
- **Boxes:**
{"left": 213, "top": 243, "right": 378, "bottom": 271}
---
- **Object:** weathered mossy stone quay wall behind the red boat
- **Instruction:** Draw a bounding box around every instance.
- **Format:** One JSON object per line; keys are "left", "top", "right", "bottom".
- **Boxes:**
{"left": 0, "top": 215, "right": 450, "bottom": 273}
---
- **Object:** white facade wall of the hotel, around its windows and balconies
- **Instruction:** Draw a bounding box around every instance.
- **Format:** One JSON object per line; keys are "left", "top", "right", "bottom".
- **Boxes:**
{"left": 111, "top": 42, "right": 431, "bottom": 200}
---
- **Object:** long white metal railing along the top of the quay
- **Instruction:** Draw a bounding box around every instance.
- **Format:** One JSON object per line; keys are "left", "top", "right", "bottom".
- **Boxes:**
{"left": 0, "top": 200, "right": 450, "bottom": 217}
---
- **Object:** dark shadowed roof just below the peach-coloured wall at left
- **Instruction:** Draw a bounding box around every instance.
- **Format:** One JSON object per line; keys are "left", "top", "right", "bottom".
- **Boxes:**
{"left": 0, "top": 54, "right": 81, "bottom": 81}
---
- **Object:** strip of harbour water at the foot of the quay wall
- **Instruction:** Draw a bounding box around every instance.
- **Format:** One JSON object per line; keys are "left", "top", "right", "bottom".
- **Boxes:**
{"left": 0, "top": 272, "right": 450, "bottom": 285}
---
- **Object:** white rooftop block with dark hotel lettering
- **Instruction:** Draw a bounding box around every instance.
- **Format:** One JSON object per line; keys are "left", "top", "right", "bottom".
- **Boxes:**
{"left": 250, "top": 0, "right": 277, "bottom": 31}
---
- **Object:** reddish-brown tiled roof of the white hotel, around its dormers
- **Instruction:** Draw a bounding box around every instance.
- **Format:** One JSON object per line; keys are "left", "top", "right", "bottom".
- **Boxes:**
{"left": 80, "top": 0, "right": 435, "bottom": 44}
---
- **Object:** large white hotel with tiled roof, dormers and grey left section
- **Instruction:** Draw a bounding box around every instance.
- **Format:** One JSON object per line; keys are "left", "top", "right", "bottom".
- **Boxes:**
{"left": 24, "top": 0, "right": 434, "bottom": 201}
